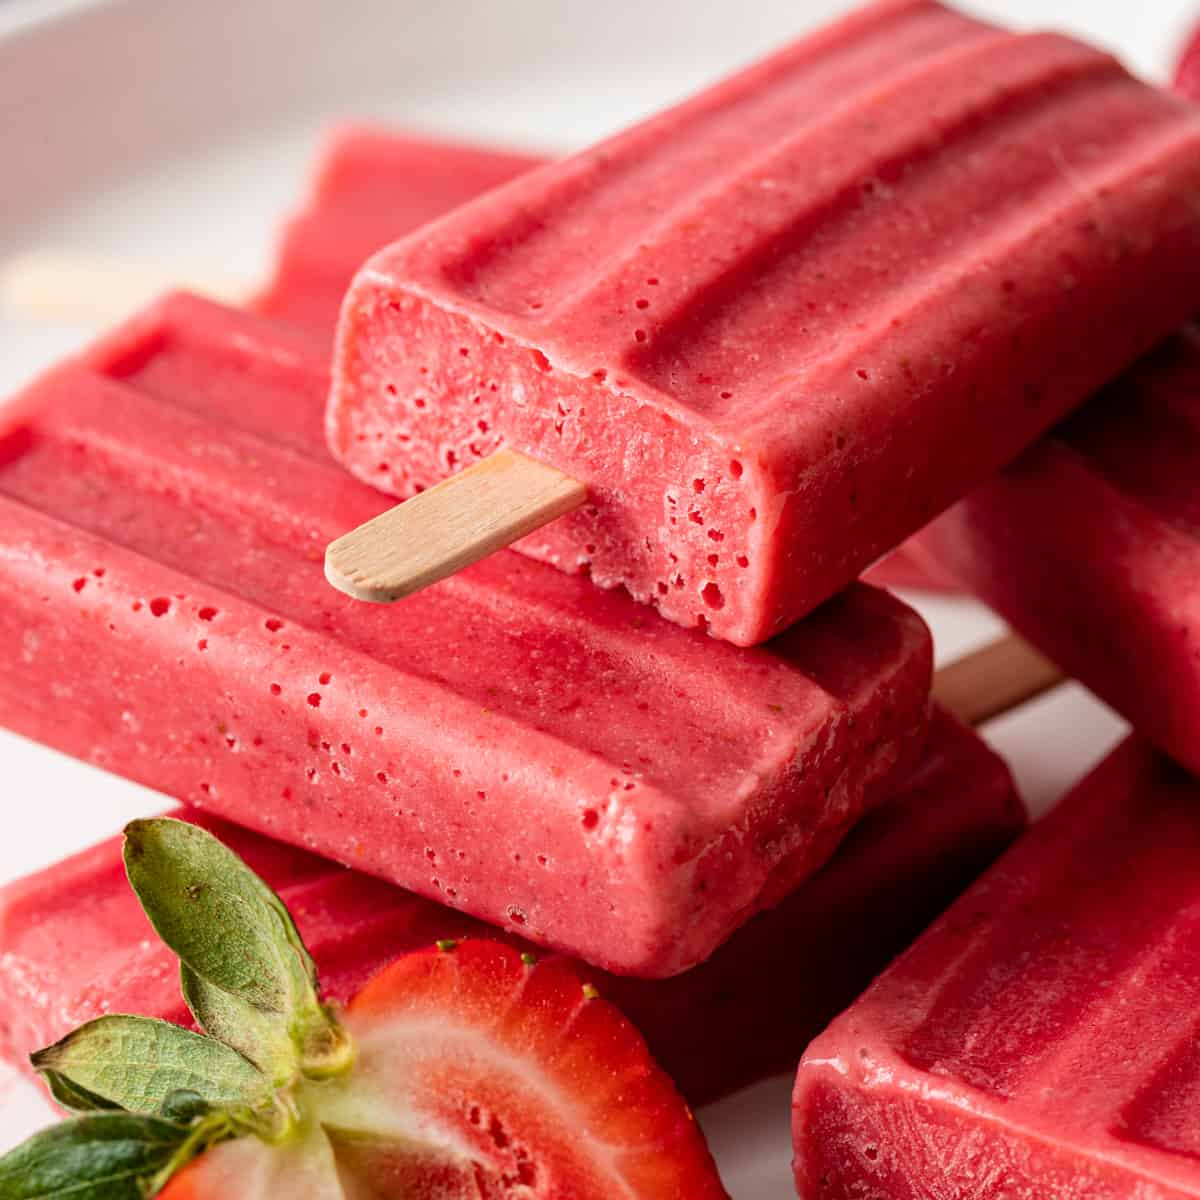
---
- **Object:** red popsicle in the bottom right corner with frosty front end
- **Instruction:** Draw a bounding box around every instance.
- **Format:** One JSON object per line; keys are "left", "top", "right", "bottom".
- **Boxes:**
{"left": 794, "top": 740, "right": 1200, "bottom": 1200}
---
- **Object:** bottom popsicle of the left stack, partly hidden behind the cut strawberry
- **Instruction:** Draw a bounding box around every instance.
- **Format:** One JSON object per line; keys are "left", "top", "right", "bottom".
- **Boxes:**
{"left": 0, "top": 716, "right": 1024, "bottom": 1104}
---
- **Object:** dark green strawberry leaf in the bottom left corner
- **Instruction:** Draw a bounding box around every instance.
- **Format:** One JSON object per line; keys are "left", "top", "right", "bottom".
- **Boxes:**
{"left": 0, "top": 1112, "right": 191, "bottom": 1200}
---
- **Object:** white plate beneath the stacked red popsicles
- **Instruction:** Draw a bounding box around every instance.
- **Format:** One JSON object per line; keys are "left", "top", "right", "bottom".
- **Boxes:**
{"left": 0, "top": 0, "right": 1171, "bottom": 1200}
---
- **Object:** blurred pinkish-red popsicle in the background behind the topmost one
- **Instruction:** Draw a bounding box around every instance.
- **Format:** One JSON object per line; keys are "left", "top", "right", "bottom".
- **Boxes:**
{"left": 253, "top": 124, "right": 542, "bottom": 337}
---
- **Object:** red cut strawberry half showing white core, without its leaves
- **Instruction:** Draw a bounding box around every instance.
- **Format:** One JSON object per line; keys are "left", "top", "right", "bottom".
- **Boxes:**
{"left": 161, "top": 940, "right": 726, "bottom": 1200}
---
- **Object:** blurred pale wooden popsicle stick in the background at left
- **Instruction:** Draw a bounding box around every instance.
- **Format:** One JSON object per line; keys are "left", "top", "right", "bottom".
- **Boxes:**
{"left": 0, "top": 250, "right": 253, "bottom": 324}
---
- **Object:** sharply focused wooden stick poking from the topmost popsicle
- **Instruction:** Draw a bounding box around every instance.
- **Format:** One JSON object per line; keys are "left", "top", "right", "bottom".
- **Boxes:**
{"left": 325, "top": 449, "right": 588, "bottom": 604}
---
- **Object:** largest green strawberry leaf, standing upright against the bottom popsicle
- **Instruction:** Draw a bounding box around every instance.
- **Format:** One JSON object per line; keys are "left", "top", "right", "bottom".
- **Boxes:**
{"left": 125, "top": 817, "right": 336, "bottom": 1060}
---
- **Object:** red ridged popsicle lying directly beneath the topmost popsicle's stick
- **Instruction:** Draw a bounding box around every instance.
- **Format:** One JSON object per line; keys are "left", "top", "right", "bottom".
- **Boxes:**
{"left": 0, "top": 288, "right": 931, "bottom": 976}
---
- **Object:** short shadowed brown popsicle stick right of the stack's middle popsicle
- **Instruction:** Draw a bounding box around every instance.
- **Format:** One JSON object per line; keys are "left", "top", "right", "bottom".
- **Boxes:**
{"left": 934, "top": 634, "right": 1066, "bottom": 725}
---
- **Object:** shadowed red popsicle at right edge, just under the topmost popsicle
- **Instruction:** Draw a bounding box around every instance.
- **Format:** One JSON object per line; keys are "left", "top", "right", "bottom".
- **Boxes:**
{"left": 910, "top": 326, "right": 1200, "bottom": 772}
